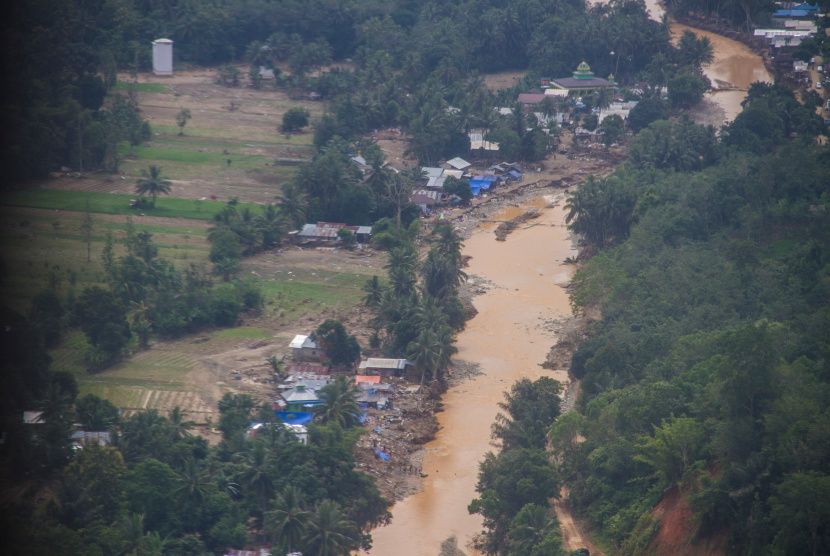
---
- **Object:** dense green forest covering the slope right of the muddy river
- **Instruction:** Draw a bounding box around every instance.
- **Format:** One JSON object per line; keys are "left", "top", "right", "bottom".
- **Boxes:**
{"left": 470, "top": 84, "right": 830, "bottom": 555}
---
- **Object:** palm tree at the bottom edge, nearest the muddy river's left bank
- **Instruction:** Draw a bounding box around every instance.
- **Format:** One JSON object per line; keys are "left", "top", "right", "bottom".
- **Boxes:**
{"left": 303, "top": 500, "right": 360, "bottom": 556}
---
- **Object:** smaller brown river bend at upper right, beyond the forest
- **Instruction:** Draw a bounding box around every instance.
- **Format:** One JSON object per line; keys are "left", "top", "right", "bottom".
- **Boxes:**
{"left": 671, "top": 23, "right": 773, "bottom": 122}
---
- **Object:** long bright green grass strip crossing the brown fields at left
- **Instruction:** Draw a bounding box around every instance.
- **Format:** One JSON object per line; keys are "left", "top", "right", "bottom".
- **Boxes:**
{"left": 0, "top": 189, "right": 259, "bottom": 220}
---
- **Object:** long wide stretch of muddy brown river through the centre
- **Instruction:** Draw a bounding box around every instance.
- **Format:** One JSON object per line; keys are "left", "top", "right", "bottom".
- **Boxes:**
{"left": 370, "top": 195, "right": 576, "bottom": 556}
